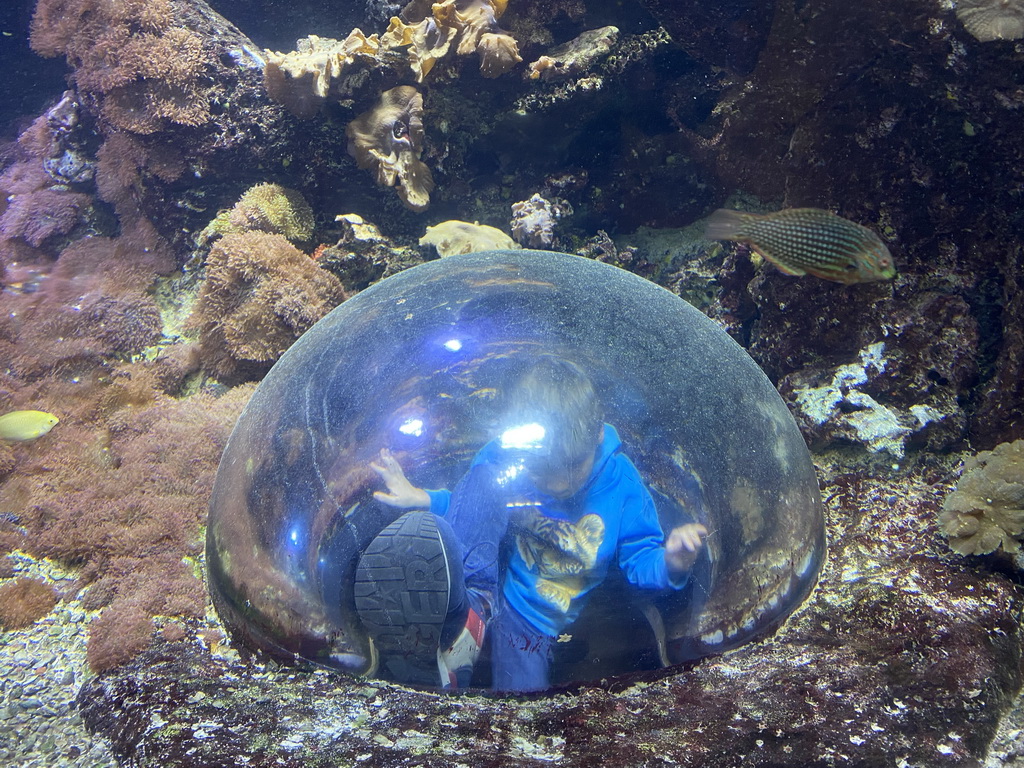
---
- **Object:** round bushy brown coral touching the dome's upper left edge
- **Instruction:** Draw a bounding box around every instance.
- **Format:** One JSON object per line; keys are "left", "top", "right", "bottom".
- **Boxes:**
{"left": 189, "top": 231, "right": 345, "bottom": 381}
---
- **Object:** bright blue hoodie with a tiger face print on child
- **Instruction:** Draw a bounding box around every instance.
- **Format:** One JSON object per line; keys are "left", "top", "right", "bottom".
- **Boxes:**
{"left": 428, "top": 424, "right": 688, "bottom": 636}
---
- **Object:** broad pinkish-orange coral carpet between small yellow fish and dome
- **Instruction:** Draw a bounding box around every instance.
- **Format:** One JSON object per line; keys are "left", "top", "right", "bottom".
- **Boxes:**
{"left": 0, "top": 354, "right": 252, "bottom": 669}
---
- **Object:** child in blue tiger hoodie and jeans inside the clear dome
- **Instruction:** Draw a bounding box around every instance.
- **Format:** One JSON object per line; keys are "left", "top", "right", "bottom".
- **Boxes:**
{"left": 357, "top": 355, "right": 708, "bottom": 691}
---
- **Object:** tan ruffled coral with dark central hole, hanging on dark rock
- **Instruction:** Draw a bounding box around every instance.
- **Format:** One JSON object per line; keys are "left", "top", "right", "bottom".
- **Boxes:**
{"left": 345, "top": 85, "right": 434, "bottom": 211}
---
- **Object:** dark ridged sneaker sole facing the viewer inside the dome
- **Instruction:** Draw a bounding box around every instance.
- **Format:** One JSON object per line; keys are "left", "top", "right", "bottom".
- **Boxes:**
{"left": 354, "top": 512, "right": 452, "bottom": 686}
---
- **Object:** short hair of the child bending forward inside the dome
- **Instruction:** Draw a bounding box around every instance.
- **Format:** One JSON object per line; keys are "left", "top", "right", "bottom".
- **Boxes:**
{"left": 507, "top": 354, "right": 603, "bottom": 465}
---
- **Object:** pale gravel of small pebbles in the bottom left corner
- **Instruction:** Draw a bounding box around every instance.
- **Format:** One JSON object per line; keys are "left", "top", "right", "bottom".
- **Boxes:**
{"left": 0, "top": 553, "right": 118, "bottom": 768}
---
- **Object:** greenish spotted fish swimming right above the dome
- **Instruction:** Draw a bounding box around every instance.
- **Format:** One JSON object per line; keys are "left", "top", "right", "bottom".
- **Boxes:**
{"left": 705, "top": 208, "right": 896, "bottom": 285}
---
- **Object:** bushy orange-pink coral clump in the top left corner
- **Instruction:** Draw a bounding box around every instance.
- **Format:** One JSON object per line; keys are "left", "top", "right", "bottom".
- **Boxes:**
{"left": 31, "top": 0, "right": 210, "bottom": 134}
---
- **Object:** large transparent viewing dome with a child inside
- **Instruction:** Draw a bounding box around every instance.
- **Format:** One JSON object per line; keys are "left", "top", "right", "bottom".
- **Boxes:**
{"left": 207, "top": 251, "right": 824, "bottom": 689}
